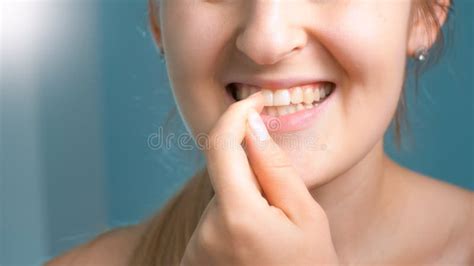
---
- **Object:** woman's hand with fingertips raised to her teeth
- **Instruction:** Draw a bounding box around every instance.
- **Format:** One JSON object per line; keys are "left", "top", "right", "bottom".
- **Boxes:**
{"left": 181, "top": 92, "right": 338, "bottom": 266}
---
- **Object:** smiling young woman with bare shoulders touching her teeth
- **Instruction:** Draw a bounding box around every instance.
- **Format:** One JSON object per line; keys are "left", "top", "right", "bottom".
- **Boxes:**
{"left": 49, "top": 0, "right": 474, "bottom": 266}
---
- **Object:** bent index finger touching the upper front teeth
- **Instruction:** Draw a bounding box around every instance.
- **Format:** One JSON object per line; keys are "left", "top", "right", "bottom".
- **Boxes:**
{"left": 204, "top": 92, "right": 264, "bottom": 210}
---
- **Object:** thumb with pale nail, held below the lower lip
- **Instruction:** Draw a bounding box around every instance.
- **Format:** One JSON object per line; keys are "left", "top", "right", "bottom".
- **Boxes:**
{"left": 245, "top": 110, "right": 319, "bottom": 223}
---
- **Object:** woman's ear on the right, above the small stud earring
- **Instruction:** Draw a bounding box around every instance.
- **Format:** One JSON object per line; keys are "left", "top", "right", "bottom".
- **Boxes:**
{"left": 407, "top": 0, "right": 451, "bottom": 56}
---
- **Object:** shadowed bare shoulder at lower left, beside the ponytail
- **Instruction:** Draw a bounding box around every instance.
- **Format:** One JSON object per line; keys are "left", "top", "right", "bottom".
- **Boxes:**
{"left": 45, "top": 224, "right": 146, "bottom": 266}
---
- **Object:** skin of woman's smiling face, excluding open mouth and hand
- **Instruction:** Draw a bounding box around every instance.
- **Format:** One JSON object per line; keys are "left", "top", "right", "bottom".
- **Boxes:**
{"left": 158, "top": 0, "right": 420, "bottom": 187}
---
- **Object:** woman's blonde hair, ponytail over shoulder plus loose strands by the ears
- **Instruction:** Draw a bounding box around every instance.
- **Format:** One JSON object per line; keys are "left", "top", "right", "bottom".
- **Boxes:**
{"left": 129, "top": 0, "right": 452, "bottom": 266}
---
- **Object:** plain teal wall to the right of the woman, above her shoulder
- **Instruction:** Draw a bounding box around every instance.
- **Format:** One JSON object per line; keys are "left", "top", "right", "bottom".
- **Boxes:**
{"left": 386, "top": 0, "right": 474, "bottom": 190}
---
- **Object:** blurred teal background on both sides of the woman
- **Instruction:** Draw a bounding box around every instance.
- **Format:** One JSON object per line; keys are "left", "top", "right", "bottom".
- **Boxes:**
{"left": 0, "top": 0, "right": 474, "bottom": 265}
